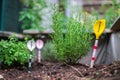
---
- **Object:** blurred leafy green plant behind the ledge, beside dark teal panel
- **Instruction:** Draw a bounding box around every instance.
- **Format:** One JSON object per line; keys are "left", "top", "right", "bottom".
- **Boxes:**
{"left": 19, "top": 0, "right": 46, "bottom": 31}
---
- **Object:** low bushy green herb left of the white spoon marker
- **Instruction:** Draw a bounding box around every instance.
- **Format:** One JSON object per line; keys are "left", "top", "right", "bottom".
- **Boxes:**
{"left": 0, "top": 36, "right": 29, "bottom": 66}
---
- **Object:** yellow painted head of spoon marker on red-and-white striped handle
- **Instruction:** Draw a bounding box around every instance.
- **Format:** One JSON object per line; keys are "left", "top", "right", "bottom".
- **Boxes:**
{"left": 94, "top": 19, "right": 106, "bottom": 39}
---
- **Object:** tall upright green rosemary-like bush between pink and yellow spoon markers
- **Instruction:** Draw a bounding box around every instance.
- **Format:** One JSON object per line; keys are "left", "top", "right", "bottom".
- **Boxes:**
{"left": 51, "top": 12, "right": 92, "bottom": 63}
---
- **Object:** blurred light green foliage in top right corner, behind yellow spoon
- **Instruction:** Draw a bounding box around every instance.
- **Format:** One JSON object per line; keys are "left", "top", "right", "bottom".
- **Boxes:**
{"left": 102, "top": 0, "right": 120, "bottom": 28}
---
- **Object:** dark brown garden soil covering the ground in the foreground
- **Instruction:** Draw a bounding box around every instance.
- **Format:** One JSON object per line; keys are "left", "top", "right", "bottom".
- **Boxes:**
{"left": 0, "top": 62, "right": 120, "bottom": 80}
